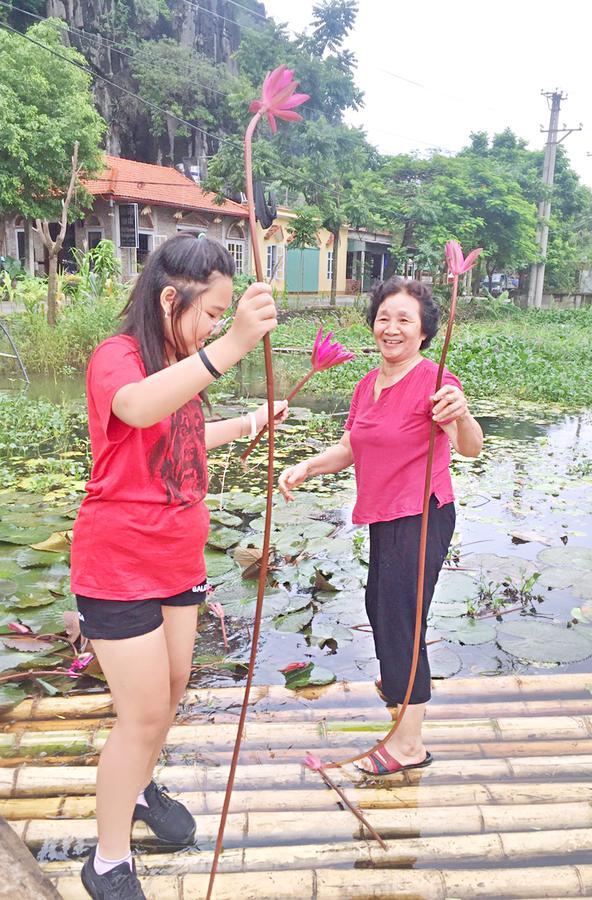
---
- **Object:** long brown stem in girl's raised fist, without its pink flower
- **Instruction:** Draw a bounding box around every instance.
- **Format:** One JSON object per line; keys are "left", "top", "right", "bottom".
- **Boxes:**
{"left": 206, "top": 112, "right": 275, "bottom": 900}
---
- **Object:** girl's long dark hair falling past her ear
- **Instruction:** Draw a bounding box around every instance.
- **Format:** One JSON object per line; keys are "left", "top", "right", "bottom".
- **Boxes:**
{"left": 121, "top": 232, "right": 234, "bottom": 375}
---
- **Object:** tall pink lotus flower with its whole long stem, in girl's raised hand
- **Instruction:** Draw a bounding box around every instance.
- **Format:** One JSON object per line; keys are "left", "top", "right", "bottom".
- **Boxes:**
{"left": 206, "top": 66, "right": 308, "bottom": 900}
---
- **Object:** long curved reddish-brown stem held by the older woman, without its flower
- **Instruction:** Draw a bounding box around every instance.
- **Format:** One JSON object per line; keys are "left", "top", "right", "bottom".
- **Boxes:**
{"left": 324, "top": 275, "right": 458, "bottom": 769}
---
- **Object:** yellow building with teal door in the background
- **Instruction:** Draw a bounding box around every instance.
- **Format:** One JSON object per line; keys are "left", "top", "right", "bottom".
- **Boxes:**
{"left": 251, "top": 206, "right": 348, "bottom": 296}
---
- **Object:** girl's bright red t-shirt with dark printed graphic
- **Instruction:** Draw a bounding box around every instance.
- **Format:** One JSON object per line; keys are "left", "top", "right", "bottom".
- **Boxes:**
{"left": 71, "top": 335, "right": 209, "bottom": 600}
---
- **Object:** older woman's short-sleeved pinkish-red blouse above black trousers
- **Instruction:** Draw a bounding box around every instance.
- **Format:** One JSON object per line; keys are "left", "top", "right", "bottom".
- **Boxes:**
{"left": 345, "top": 359, "right": 462, "bottom": 524}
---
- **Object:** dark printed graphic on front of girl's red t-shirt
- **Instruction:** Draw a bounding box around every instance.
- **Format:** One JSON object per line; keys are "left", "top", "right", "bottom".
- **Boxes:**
{"left": 149, "top": 400, "right": 208, "bottom": 506}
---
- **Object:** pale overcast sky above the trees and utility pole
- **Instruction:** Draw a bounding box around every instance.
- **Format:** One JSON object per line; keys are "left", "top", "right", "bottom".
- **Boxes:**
{"left": 264, "top": 0, "right": 592, "bottom": 187}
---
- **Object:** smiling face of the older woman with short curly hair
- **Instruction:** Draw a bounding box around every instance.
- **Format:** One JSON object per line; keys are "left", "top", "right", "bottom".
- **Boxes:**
{"left": 373, "top": 291, "right": 425, "bottom": 363}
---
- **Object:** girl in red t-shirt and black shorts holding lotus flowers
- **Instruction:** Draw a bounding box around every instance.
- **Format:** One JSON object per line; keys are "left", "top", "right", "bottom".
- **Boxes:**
{"left": 72, "top": 234, "right": 287, "bottom": 900}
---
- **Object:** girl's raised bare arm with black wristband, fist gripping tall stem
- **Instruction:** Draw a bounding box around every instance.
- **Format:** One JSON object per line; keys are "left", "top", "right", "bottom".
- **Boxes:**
{"left": 111, "top": 284, "right": 277, "bottom": 430}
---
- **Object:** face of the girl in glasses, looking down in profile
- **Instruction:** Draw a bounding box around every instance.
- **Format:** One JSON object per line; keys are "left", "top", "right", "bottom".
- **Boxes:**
{"left": 161, "top": 272, "right": 232, "bottom": 354}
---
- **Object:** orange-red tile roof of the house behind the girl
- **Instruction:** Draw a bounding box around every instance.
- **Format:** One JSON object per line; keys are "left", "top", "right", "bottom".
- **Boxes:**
{"left": 83, "top": 156, "right": 247, "bottom": 219}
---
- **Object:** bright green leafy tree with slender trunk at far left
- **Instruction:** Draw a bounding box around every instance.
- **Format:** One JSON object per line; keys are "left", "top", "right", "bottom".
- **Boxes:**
{"left": 0, "top": 20, "right": 105, "bottom": 324}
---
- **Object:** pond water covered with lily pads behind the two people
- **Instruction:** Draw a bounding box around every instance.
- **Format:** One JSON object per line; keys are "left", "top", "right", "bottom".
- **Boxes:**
{"left": 0, "top": 369, "right": 592, "bottom": 702}
